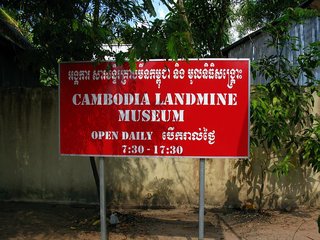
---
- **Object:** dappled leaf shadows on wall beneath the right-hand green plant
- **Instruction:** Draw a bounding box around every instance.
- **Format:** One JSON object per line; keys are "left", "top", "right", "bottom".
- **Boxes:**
{"left": 232, "top": 152, "right": 319, "bottom": 211}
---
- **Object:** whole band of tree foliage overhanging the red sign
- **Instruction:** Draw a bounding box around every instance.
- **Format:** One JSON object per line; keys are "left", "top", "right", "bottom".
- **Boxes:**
{"left": 0, "top": 0, "right": 238, "bottom": 83}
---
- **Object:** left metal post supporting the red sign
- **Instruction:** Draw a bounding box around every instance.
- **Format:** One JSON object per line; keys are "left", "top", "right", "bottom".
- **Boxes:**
{"left": 99, "top": 157, "right": 107, "bottom": 240}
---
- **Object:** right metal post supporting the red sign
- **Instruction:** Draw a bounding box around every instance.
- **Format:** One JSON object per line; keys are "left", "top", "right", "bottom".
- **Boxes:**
{"left": 199, "top": 158, "right": 205, "bottom": 240}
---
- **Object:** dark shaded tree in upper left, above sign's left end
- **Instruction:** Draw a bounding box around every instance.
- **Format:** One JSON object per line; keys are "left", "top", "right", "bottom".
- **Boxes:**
{"left": 0, "top": 0, "right": 155, "bottom": 85}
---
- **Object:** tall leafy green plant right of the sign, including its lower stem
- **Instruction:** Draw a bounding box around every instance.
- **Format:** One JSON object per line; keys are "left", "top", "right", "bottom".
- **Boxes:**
{"left": 248, "top": 8, "right": 320, "bottom": 209}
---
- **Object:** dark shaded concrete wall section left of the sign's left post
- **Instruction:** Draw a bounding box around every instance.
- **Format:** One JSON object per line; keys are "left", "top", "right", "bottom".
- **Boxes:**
{"left": 0, "top": 88, "right": 95, "bottom": 201}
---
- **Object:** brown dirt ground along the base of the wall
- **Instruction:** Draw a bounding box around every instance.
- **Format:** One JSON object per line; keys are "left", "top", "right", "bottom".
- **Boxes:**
{"left": 0, "top": 203, "right": 320, "bottom": 240}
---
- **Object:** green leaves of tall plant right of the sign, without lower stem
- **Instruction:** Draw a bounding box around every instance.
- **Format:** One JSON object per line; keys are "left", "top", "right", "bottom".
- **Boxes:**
{"left": 251, "top": 9, "right": 320, "bottom": 173}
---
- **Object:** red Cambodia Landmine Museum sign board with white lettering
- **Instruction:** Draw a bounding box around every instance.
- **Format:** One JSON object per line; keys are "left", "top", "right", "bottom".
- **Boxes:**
{"left": 60, "top": 59, "right": 249, "bottom": 158}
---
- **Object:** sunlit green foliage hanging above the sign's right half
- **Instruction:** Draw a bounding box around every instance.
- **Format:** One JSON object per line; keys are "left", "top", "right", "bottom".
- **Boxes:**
{"left": 117, "top": 0, "right": 232, "bottom": 62}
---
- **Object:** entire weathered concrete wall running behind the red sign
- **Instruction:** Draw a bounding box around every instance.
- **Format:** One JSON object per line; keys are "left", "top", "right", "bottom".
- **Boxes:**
{"left": 0, "top": 88, "right": 320, "bottom": 207}
